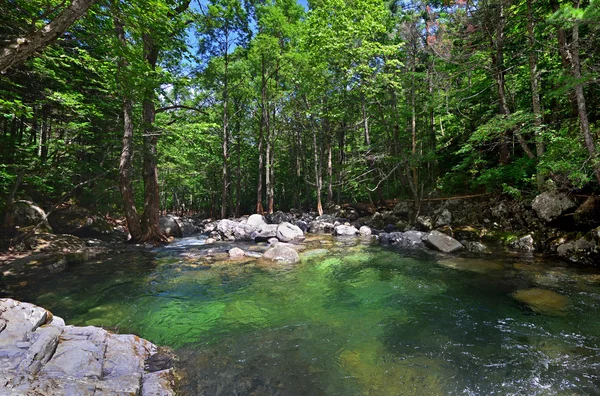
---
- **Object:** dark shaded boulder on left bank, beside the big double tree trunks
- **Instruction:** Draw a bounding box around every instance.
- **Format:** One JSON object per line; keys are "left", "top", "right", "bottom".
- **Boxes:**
{"left": 48, "top": 205, "right": 112, "bottom": 238}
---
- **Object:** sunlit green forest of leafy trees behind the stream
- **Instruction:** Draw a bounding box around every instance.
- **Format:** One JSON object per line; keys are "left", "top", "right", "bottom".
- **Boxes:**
{"left": 0, "top": 0, "right": 600, "bottom": 240}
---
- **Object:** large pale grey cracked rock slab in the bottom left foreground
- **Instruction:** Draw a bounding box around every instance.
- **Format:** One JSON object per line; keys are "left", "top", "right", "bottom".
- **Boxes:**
{"left": 0, "top": 299, "right": 174, "bottom": 395}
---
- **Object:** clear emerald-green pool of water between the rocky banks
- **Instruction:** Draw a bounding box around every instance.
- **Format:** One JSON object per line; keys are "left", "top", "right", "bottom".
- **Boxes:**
{"left": 2, "top": 238, "right": 600, "bottom": 395}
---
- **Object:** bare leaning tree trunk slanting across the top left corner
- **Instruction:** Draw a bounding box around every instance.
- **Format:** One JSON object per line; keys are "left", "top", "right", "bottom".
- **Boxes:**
{"left": 0, "top": 0, "right": 96, "bottom": 73}
